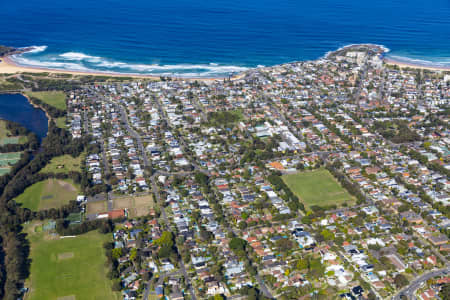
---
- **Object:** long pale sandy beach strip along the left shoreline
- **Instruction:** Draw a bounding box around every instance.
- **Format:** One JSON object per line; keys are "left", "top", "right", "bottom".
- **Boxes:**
{"left": 0, "top": 56, "right": 223, "bottom": 81}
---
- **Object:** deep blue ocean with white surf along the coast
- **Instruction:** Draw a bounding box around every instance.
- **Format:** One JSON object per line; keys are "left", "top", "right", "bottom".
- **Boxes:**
{"left": 0, "top": 0, "right": 450, "bottom": 76}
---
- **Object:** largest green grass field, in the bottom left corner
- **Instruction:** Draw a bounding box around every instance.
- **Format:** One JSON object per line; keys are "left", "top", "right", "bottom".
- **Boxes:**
{"left": 25, "top": 224, "right": 119, "bottom": 300}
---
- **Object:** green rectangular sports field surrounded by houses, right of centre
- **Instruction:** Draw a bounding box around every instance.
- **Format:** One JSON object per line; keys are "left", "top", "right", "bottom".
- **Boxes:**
{"left": 282, "top": 169, "right": 355, "bottom": 208}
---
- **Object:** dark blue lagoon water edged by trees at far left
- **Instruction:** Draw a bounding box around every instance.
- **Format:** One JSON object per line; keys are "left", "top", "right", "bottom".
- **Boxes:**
{"left": 0, "top": 94, "right": 48, "bottom": 139}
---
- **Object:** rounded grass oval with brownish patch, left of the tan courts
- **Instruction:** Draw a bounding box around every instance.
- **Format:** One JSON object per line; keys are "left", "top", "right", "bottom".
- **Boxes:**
{"left": 14, "top": 179, "right": 78, "bottom": 211}
